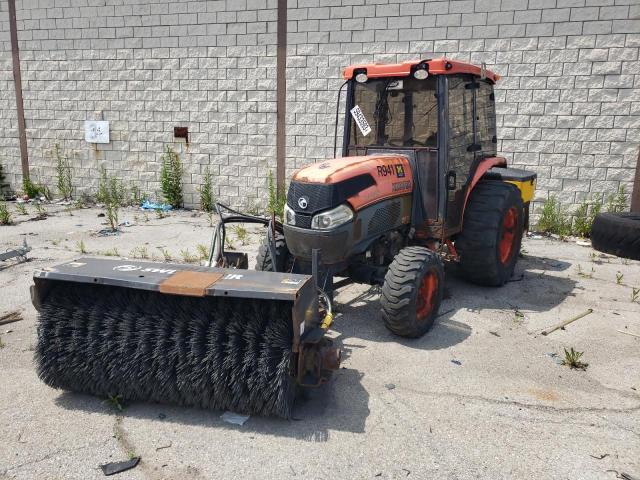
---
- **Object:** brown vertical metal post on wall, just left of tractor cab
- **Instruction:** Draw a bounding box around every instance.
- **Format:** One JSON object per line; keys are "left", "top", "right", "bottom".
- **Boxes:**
{"left": 276, "top": 0, "right": 287, "bottom": 195}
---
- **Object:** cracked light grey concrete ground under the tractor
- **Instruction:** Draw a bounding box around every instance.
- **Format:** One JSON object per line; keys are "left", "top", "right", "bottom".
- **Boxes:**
{"left": 0, "top": 206, "right": 640, "bottom": 479}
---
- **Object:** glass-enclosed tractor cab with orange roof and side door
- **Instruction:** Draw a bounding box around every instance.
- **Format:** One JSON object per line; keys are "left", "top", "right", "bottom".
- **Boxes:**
{"left": 342, "top": 58, "right": 499, "bottom": 237}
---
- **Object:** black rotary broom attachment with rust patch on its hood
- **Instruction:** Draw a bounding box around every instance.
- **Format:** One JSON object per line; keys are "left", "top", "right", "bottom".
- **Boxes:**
{"left": 31, "top": 258, "right": 339, "bottom": 418}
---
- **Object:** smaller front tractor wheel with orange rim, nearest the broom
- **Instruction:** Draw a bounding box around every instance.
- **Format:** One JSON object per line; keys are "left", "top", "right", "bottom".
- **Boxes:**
{"left": 380, "top": 247, "right": 444, "bottom": 338}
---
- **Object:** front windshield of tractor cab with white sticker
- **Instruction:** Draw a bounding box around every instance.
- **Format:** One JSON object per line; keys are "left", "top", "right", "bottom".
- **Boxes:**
{"left": 349, "top": 77, "right": 438, "bottom": 148}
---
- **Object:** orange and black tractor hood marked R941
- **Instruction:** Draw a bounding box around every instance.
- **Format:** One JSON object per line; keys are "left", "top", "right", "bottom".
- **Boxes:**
{"left": 287, "top": 154, "right": 413, "bottom": 221}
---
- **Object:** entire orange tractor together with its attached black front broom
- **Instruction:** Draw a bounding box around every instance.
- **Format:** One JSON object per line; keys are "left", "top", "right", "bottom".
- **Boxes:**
{"left": 32, "top": 58, "right": 536, "bottom": 417}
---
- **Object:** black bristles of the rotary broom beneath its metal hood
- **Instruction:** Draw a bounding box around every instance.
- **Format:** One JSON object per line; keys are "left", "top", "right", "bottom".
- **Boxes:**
{"left": 35, "top": 284, "right": 295, "bottom": 418}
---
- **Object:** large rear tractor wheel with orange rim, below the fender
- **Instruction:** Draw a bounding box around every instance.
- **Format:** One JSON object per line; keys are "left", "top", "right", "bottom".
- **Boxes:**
{"left": 455, "top": 181, "right": 524, "bottom": 287}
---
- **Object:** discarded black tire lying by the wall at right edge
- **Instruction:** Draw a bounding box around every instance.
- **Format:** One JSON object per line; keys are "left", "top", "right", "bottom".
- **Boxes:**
{"left": 591, "top": 212, "right": 640, "bottom": 260}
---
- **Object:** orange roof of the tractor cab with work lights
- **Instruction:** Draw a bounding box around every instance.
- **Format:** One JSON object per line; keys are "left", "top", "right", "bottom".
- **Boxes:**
{"left": 342, "top": 57, "right": 500, "bottom": 83}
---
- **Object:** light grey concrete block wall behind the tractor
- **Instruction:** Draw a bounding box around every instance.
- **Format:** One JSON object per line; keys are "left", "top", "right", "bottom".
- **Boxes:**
{"left": 0, "top": 0, "right": 640, "bottom": 212}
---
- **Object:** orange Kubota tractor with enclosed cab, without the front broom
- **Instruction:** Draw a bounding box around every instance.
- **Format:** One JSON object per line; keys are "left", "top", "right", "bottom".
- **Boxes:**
{"left": 257, "top": 58, "right": 536, "bottom": 337}
